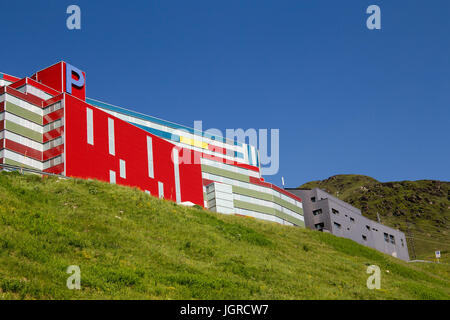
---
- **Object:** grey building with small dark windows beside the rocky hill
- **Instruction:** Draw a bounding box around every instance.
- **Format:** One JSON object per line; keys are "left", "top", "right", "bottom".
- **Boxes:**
{"left": 287, "top": 188, "right": 409, "bottom": 261}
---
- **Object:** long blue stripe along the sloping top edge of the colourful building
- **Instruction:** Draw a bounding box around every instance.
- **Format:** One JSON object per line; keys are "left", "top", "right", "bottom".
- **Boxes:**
{"left": 86, "top": 98, "right": 242, "bottom": 147}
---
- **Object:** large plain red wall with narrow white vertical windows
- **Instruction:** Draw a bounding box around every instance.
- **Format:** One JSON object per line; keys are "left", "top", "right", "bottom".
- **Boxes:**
{"left": 65, "top": 94, "right": 203, "bottom": 206}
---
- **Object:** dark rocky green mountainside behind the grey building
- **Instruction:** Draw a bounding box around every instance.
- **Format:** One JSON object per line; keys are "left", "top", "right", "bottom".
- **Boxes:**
{"left": 300, "top": 175, "right": 450, "bottom": 262}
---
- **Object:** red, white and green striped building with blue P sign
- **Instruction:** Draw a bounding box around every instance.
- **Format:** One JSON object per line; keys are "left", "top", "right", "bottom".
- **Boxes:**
{"left": 0, "top": 62, "right": 304, "bottom": 226}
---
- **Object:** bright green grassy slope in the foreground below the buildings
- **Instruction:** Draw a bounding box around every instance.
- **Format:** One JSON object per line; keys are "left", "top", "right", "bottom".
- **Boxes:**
{"left": 0, "top": 173, "right": 450, "bottom": 299}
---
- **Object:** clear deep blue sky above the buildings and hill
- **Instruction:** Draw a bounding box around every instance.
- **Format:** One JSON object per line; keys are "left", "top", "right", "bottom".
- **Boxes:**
{"left": 0, "top": 0, "right": 450, "bottom": 186}
